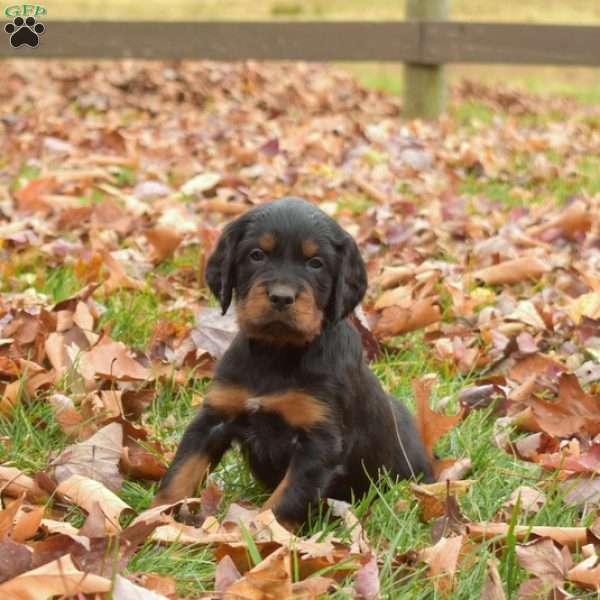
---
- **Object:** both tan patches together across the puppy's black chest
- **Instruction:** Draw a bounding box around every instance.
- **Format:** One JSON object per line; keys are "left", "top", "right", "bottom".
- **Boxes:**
{"left": 205, "top": 382, "right": 331, "bottom": 429}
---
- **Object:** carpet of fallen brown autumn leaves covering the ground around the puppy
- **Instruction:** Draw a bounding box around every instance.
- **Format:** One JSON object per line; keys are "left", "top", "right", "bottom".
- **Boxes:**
{"left": 0, "top": 55, "right": 600, "bottom": 599}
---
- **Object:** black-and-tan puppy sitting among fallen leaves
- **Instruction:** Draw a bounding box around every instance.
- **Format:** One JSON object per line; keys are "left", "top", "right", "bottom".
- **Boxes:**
{"left": 153, "top": 198, "right": 432, "bottom": 523}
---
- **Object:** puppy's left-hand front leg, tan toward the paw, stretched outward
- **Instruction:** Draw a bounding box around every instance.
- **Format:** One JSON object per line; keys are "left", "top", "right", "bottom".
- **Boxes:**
{"left": 152, "top": 407, "right": 233, "bottom": 506}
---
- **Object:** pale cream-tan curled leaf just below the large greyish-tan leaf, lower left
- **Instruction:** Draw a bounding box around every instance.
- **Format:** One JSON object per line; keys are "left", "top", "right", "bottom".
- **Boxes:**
{"left": 56, "top": 475, "right": 132, "bottom": 533}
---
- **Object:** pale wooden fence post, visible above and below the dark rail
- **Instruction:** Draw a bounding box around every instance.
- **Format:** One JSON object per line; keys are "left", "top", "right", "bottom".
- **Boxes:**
{"left": 404, "top": 0, "right": 450, "bottom": 119}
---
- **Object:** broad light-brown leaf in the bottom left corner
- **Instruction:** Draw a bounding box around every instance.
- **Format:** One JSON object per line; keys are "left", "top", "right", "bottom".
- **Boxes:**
{"left": 0, "top": 555, "right": 112, "bottom": 600}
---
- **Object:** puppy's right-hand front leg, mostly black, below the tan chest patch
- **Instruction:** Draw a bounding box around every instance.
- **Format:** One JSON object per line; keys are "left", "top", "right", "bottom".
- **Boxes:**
{"left": 263, "top": 431, "right": 341, "bottom": 524}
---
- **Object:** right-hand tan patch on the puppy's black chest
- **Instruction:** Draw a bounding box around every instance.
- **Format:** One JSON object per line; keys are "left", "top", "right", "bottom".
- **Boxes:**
{"left": 257, "top": 390, "right": 330, "bottom": 429}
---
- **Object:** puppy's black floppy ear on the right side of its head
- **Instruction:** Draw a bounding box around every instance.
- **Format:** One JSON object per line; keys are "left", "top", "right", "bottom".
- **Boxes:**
{"left": 327, "top": 232, "right": 367, "bottom": 323}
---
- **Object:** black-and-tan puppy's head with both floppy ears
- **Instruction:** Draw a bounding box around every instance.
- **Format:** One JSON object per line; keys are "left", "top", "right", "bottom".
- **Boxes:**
{"left": 206, "top": 198, "right": 367, "bottom": 346}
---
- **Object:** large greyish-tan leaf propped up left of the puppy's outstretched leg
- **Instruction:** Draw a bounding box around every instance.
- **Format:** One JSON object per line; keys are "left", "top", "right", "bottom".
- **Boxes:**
{"left": 52, "top": 423, "right": 123, "bottom": 492}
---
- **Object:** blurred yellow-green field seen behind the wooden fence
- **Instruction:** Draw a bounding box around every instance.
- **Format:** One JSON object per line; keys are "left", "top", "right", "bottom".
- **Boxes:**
{"left": 40, "top": 0, "right": 600, "bottom": 103}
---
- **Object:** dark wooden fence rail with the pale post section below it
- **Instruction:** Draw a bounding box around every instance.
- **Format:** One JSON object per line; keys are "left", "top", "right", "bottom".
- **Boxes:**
{"left": 0, "top": 18, "right": 600, "bottom": 116}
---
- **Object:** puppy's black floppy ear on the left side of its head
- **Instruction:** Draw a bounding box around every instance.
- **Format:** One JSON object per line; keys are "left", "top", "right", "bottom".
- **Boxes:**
{"left": 206, "top": 215, "right": 248, "bottom": 314}
